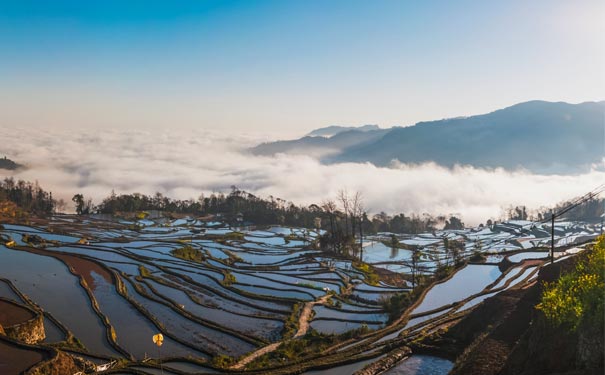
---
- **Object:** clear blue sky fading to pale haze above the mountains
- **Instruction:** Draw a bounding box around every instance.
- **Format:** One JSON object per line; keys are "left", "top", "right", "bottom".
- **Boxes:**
{"left": 0, "top": 0, "right": 605, "bottom": 135}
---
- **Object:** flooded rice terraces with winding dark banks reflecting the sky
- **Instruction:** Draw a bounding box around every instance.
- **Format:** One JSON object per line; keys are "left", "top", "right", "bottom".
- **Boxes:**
{"left": 0, "top": 215, "right": 598, "bottom": 374}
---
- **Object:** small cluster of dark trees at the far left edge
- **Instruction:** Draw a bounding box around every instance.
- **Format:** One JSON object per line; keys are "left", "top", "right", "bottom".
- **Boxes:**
{"left": 0, "top": 177, "right": 56, "bottom": 215}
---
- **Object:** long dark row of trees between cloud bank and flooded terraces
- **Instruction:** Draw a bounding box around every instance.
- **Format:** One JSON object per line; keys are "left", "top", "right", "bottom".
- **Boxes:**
{"left": 81, "top": 186, "right": 464, "bottom": 239}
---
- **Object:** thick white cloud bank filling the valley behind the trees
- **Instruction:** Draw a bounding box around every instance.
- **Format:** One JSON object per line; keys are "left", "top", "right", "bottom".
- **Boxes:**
{"left": 0, "top": 128, "right": 605, "bottom": 224}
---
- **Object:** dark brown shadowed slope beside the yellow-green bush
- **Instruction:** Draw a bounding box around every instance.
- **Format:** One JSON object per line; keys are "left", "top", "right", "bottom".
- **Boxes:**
{"left": 413, "top": 255, "right": 603, "bottom": 375}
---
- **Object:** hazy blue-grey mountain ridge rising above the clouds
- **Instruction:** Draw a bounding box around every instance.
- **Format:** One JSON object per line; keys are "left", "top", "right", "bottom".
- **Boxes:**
{"left": 252, "top": 100, "right": 605, "bottom": 174}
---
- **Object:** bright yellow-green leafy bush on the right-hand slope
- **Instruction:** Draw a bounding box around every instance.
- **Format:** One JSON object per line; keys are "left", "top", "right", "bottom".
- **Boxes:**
{"left": 536, "top": 235, "right": 605, "bottom": 331}
